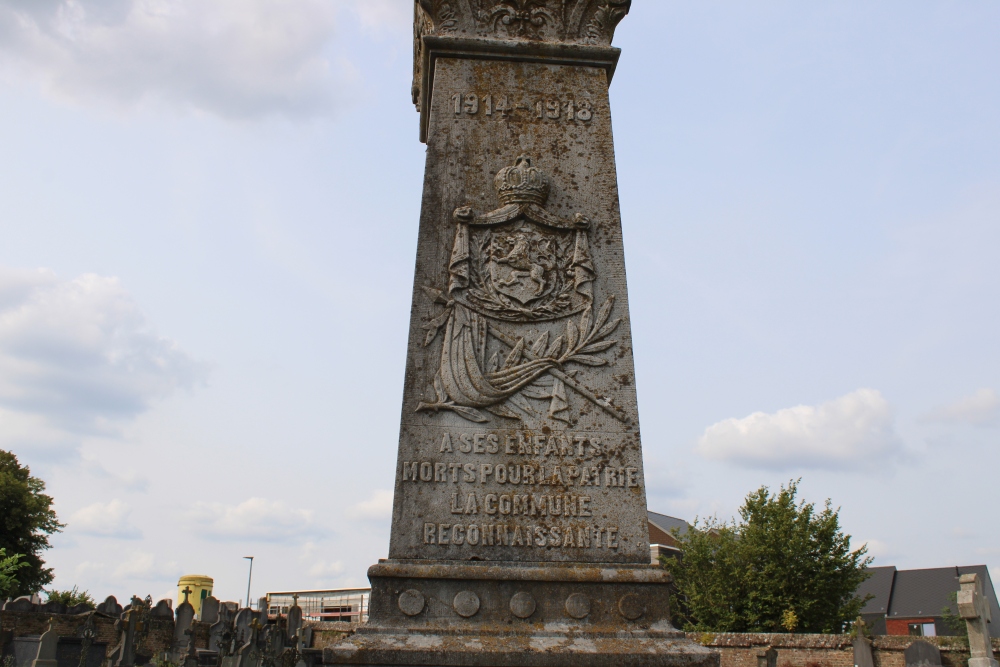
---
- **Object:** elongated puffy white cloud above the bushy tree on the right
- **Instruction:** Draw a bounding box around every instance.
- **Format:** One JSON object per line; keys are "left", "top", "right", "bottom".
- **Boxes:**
{"left": 697, "top": 389, "right": 901, "bottom": 470}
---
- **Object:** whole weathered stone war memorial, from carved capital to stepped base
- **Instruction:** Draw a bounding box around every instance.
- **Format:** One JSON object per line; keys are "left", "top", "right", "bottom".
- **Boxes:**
{"left": 323, "top": 0, "right": 719, "bottom": 667}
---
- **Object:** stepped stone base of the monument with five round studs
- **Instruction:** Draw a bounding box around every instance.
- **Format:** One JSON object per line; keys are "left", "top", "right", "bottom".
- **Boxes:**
{"left": 323, "top": 561, "right": 719, "bottom": 667}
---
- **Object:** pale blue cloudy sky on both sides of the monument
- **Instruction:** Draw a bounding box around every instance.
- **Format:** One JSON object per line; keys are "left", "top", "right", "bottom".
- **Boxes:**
{"left": 0, "top": 0, "right": 1000, "bottom": 599}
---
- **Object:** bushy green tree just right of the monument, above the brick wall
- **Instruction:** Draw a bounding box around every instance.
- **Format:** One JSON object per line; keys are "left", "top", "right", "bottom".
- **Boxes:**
{"left": 663, "top": 480, "right": 872, "bottom": 632}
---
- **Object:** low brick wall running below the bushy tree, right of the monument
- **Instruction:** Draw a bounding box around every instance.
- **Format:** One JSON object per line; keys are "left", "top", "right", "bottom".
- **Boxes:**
{"left": 688, "top": 632, "right": 1000, "bottom": 667}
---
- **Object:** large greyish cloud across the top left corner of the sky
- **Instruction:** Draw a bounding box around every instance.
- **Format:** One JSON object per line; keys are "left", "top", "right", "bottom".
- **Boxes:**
{"left": 0, "top": 0, "right": 352, "bottom": 117}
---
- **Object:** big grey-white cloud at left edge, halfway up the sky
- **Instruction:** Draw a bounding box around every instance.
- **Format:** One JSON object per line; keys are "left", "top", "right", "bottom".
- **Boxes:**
{"left": 0, "top": 269, "right": 205, "bottom": 453}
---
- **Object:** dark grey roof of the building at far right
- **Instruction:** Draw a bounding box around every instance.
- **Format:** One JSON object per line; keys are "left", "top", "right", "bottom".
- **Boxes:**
{"left": 892, "top": 565, "right": 1000, "bottom": 626}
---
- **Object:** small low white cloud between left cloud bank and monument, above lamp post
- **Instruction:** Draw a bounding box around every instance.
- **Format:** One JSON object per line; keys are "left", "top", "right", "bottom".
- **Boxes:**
{"left": 187, "top": 498, "right": 320, "bottom": 542}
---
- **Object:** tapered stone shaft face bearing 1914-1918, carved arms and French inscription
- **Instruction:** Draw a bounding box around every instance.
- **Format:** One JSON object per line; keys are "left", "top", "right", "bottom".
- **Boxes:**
{"left": 389, "top": 53, "right": 649, "bottom": 563}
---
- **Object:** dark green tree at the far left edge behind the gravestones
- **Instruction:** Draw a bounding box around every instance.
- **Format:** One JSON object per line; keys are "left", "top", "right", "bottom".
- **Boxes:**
{"left": 0, "top": 450, "right": 63, "bottom": 596}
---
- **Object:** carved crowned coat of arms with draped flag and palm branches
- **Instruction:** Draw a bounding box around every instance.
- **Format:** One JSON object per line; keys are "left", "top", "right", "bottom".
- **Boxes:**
{"left": 417, "top": 155, "right": 623, "bottom": 422}
